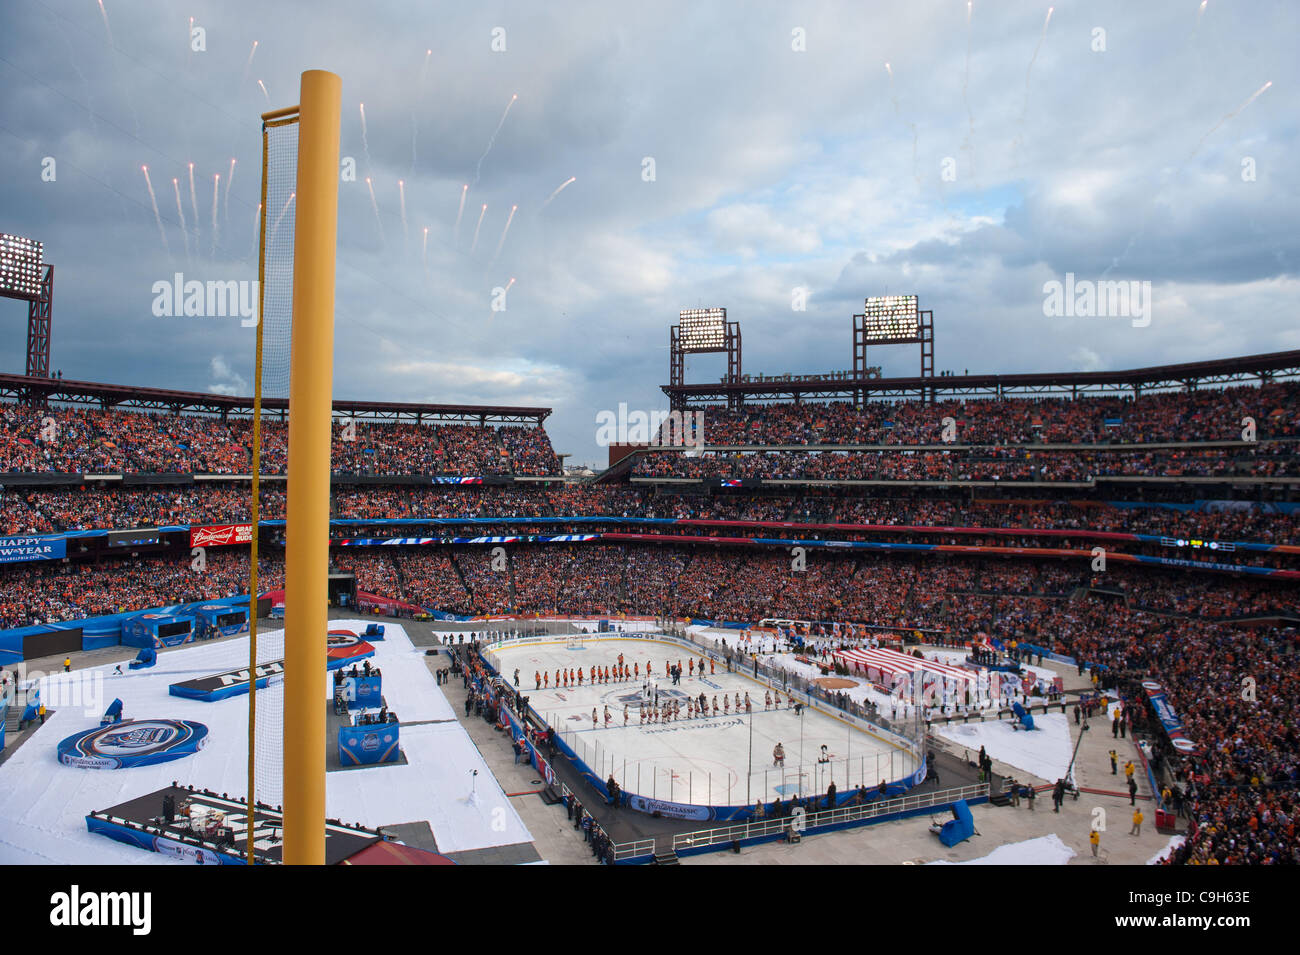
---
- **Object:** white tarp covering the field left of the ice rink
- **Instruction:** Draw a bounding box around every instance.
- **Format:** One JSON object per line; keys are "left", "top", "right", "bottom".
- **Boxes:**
{"left": 0, "top": 620, "right": 532, "bottom": 865}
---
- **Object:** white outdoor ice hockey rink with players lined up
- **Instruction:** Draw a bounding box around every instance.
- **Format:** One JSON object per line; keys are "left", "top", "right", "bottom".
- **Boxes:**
{"left": 489, "top": 635, "right": 919, "bottom": 806}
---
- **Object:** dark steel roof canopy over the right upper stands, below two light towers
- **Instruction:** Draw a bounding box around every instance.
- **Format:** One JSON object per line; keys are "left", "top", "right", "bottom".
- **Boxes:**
{"left": 660, "top": 351, "right": 1300, "bottom": 408}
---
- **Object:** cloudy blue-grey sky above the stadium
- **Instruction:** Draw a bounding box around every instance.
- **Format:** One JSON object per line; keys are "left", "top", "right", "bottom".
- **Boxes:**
{"left": 0, "top": 0, "right": 1300, "bottom": 463}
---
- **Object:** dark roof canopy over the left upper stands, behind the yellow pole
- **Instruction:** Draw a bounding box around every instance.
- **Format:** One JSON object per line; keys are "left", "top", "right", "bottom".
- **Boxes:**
{"left": 0, "top": 374, "right": 551, "bottom": 427}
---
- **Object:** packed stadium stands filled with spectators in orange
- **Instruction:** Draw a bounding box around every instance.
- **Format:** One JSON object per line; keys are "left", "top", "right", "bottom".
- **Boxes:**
{"left": 0, "top": 356, "right": 1300, "bottom": 864}
